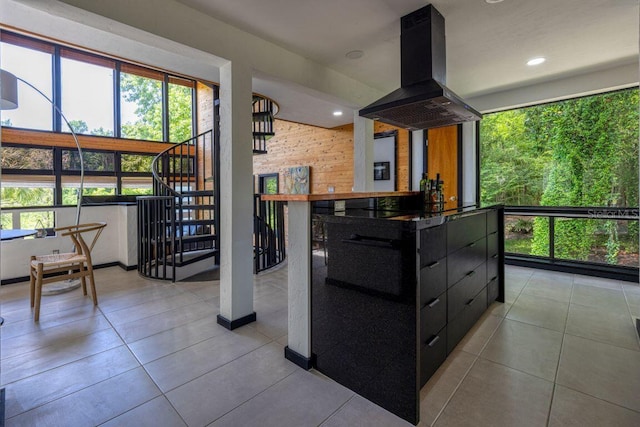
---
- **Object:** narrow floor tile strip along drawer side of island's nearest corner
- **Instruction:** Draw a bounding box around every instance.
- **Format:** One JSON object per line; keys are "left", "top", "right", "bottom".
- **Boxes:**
{"left": 420, "top": 350, "right": 477, "bottom": 426}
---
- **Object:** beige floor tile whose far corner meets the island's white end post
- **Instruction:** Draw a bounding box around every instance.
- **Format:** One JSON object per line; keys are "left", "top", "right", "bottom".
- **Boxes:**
{"left": 167, "top": 343, "right": 299, "bottom": 426}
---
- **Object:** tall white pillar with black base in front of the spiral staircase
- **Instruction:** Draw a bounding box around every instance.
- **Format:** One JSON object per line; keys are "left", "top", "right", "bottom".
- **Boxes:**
{"left": 217, "top": 61, "right": 256, "bottom": 329}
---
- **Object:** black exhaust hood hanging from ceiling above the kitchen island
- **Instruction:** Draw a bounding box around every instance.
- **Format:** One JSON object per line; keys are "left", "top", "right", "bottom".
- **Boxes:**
{"left": 360, "top": 5, "right": 482, "bottom": 130}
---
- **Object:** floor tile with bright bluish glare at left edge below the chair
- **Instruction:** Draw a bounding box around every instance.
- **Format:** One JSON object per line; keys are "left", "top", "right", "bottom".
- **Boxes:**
{"left": 0, "top": 329, "right": 124, "bottom": 384}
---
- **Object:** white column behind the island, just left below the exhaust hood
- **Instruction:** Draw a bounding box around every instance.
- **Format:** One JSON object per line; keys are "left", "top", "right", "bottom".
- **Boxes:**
{"left": 353, "top": 111, "right": 373, "bottom": 191}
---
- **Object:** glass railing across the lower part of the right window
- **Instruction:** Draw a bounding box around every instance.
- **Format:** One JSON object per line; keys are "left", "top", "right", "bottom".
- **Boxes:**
{"left": 504, "top": 206, "right": 640, "bottom": 268}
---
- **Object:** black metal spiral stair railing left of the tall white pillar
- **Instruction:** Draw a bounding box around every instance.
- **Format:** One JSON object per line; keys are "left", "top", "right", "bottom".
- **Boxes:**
{"left": 138, "top": 131, "right": 219, "bottom": 280}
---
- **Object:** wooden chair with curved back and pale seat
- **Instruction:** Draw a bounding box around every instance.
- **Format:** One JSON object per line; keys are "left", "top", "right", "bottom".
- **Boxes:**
{"left": 29, "top": 222, "right": 107, "bottom": 322}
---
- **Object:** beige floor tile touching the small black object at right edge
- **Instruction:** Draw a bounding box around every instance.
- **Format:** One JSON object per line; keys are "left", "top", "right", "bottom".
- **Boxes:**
{"left": 566, "top": 304, "right": 640, "bottom": 357}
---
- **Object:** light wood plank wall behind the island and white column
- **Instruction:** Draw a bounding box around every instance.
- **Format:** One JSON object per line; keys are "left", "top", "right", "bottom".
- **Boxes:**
{"left": 253, "top": 119, "right": 409, "bottom": 193}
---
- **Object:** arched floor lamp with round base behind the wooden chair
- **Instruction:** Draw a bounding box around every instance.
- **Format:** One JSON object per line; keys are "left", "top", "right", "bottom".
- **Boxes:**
{"left": 0, "top": 69, "right": 84, "bottom": 295}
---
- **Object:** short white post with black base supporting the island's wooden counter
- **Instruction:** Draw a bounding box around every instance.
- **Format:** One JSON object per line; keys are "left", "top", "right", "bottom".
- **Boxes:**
{"left": 285, "top": 201, "right": 311, "bottom": 369}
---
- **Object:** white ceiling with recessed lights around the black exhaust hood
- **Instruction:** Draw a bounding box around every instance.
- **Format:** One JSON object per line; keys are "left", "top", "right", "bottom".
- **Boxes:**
{"left": 178, "top": 0, "right": 639, "bottom": 127}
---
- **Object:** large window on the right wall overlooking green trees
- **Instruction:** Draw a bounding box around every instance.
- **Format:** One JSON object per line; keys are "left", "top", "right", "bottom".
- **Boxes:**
{"left": 480, "top": 88, "right": 638, "bottom": 266}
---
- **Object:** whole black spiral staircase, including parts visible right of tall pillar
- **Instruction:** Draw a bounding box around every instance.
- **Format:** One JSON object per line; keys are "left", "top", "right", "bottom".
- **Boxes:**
{"left": 137, "top": 96, "right": 285, "bottom": 281}
